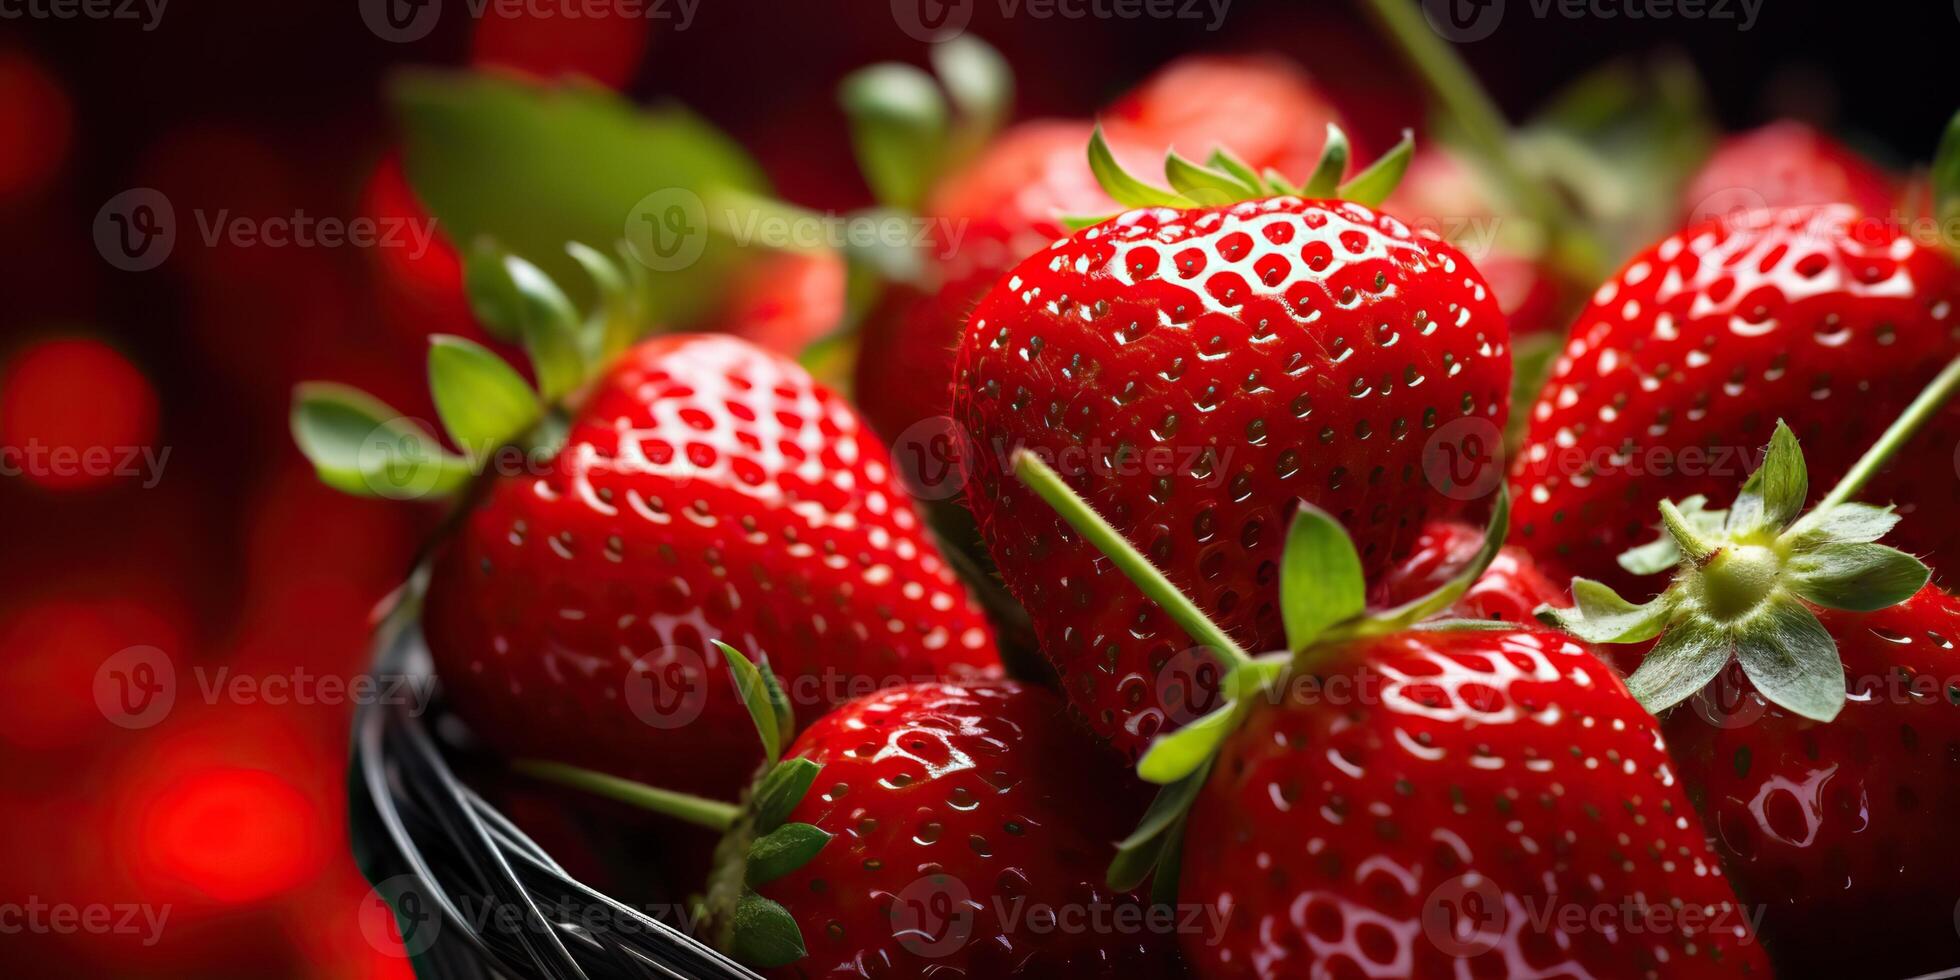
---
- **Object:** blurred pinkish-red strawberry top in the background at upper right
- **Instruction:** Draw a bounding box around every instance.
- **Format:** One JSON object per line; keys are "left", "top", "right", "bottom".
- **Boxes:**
{"left": 1682, "top": 120, "right": 1897, "bottom": 221}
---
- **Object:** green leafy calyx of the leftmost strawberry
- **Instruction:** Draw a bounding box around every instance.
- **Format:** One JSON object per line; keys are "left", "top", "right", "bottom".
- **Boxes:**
{"left": 290, "top": 243, "right": 649, "bottom": 500}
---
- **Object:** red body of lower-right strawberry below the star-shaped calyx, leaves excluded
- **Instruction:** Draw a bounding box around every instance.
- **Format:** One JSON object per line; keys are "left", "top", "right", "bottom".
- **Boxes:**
{"left": 1664, "top": 586, "right": 1960, "bottom": 980}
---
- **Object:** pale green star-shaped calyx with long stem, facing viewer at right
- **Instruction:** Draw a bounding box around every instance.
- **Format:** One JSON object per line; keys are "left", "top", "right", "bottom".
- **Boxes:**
{"left": 1537, "top": 361, "right": 1960, "bottom": 721}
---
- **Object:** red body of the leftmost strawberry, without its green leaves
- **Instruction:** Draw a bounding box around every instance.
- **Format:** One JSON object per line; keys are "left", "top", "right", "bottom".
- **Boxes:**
{"left": 423, "top": 335, "right": 996, "bottom": 798}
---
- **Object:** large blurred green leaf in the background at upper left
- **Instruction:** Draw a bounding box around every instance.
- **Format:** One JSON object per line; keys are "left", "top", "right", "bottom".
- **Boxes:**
{"left": 390, "top": 71, "right": 768, "bottom": 325}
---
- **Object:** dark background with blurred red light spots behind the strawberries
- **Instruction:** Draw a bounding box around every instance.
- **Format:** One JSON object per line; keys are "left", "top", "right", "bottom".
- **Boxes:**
{"left": 0, "top": 0, "right": 1960, "bottom": 978}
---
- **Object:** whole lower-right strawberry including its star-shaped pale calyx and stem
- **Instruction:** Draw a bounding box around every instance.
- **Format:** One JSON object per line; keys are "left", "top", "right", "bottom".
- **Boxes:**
{"left": 1541, "top": 370, "right": 1960, "bottom": 976}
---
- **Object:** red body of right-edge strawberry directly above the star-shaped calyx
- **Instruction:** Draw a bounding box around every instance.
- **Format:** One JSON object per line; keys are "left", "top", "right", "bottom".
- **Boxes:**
{"left": 1511, "top": 206, "right": 1960, "bottom": 600}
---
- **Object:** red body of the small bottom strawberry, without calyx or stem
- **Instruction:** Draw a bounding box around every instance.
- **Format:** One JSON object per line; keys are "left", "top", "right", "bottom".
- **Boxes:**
{"left": 759, "top": 682, "right": 1182, "bottom": 980}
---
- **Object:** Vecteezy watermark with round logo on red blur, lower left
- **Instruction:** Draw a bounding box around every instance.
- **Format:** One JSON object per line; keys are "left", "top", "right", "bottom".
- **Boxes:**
{"left": 94, "top": 647, "right": 435, "bottom": 729}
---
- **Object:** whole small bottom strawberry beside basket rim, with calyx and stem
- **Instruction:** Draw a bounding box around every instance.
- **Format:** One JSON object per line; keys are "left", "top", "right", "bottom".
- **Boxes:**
{"left": 525, "top": 651, "right": 1176, "bottom": 980}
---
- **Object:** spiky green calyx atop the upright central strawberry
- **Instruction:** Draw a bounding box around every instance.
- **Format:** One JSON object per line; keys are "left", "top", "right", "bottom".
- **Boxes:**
{"left": 1062, "top": 123, "right": 1415, "bottom": 231}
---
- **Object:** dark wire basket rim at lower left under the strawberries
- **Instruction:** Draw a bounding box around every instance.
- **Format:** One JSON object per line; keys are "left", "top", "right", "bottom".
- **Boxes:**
{"left": 347, "top": 576, "right": 759, "bottom": 980}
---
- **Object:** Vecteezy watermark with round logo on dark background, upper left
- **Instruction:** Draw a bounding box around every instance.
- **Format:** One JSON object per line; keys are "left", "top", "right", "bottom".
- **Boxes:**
{"left": 94, "top": 188, "right": 435, "bottom": 272}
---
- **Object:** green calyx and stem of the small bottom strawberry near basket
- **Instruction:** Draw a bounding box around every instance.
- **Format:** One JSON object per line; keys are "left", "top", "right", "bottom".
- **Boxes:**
{"left": 514, "top": 641, "right": 831, "bottom": 970}
